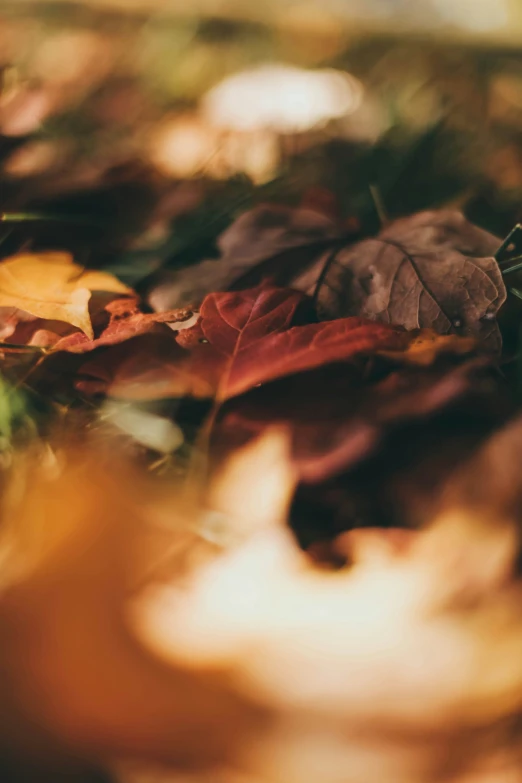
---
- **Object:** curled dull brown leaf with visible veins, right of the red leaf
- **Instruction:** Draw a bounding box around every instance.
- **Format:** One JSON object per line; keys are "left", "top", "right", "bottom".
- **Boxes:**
{"left": 317, "top": 210, "right": 506, "bottom": 351}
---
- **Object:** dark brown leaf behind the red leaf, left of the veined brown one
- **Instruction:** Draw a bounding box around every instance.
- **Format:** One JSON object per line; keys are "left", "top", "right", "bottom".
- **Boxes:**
{"left": 148, "top": 204, "right": 340, "bottom": 311}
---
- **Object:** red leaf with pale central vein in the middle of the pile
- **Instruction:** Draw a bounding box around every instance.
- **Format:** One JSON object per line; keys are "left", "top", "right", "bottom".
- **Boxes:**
{"left": 107, "top": 287, "right": 476, "bottom": 401}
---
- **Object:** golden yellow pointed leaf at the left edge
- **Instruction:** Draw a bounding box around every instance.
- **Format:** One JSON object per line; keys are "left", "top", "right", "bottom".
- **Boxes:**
{"left": 0, "top": 252, "right": 129, "bottom": 339}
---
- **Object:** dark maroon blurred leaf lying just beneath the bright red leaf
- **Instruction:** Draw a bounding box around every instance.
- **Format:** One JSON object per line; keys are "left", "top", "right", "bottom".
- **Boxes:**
{"left": 215, "top": 359, "right": 498, "bottom": 484}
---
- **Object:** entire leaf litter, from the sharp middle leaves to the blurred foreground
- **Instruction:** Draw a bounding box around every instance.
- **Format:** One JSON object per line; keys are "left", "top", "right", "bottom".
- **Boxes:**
{"left": 4, "top": 204, "right": 522, "bottom": 783}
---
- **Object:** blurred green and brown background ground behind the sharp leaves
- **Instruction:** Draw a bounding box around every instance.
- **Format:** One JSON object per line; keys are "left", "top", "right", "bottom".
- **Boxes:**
{"left": 0, "top": 0, "right": 522, "bottom": 270}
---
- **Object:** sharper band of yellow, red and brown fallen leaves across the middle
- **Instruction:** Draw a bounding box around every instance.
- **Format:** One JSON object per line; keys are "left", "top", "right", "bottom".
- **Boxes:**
{"left": 0, "top": 206, "right": 509, "bottom": 539}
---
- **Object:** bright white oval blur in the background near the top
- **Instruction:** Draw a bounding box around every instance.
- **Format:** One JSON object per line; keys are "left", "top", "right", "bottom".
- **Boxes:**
{"left": 202, "top": 65, "right": 363, "bottom": 133}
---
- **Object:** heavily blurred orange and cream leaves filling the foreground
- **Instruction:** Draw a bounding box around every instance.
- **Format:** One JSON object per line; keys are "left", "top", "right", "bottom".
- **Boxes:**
{"left": 0, "top": 422, "right": 522, "bottom": 783}
